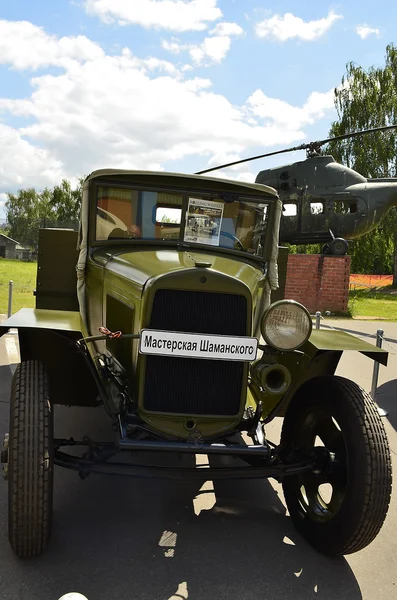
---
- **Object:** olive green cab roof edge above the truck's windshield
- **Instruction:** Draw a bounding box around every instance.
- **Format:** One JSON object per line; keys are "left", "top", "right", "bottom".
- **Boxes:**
{"left": 86, "top": 169, "right": 278, "bottom": 199}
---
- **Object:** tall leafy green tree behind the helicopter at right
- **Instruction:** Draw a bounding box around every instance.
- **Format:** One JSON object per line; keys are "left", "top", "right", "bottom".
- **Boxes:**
{"left": 326, "top": 44, "right": 397, "bottom": 284}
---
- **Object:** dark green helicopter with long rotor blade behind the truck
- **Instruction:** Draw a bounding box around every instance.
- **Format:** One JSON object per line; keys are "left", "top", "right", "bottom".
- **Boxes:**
{"left": 197, "top": 125, "right": 397, "bottom": 255}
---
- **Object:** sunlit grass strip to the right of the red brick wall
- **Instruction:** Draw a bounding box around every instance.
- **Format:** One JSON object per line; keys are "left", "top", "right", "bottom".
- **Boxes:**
{"left": 349, "top": 285, "right": 397, "bottom": 321}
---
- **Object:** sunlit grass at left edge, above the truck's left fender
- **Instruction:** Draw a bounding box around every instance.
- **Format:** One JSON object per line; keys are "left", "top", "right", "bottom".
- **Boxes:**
{"left": 0, "top": 258, "right": 37, "bottom": 314}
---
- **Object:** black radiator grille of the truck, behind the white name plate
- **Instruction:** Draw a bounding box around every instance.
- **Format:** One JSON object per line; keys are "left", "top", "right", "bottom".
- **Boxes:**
{"left": 144, "top": 290, "right": 247, "bottom": 415}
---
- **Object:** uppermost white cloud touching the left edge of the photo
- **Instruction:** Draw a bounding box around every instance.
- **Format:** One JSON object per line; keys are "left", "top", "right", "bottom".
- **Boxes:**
{"left": 0, "top": 20, "right": 104, "bottom": 70}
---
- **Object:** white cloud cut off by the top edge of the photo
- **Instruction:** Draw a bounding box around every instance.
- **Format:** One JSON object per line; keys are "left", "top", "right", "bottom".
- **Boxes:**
{"left": 84, "top": 0, "right": 222, "bottom": 31}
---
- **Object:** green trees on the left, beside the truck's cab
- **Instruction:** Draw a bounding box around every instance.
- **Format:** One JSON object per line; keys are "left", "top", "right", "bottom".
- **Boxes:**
{"left": 5, "top": 178, "right": 84, "bottom": 250}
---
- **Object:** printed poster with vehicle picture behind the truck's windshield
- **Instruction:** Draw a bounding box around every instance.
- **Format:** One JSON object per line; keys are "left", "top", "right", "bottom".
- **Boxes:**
{"left": 184, "top": 198, "right": 223, "bottom": 246}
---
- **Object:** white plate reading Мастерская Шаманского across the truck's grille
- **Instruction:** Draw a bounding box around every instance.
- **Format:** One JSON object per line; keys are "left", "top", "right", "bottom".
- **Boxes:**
{"left": 139, "top": 329, "right": 258, "bottom": 362}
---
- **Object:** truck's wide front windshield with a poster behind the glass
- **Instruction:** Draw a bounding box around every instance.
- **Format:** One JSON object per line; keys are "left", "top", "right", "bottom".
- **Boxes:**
{"left": 96, "top": 186, "right": 268, "bottom": 256}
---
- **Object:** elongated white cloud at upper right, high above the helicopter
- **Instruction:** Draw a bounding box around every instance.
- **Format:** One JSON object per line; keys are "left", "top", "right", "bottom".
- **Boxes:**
{"left": 255, "top": 11, "right": 342, "bottom": 42}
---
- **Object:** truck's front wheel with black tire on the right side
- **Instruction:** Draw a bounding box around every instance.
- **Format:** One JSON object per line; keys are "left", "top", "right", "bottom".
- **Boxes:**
{"left": 281, "top": 376, "right": 392, "bottom": 556}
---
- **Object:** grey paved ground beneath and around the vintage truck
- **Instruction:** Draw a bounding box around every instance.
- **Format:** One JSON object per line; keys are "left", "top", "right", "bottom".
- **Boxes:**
{"left": 0, "top": 321, "right": 397, "bottom": 600}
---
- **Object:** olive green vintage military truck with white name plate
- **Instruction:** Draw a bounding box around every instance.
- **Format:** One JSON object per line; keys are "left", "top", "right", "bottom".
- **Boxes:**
{"left": 1, "top": 170, "right": 391, "bottom": 557}
